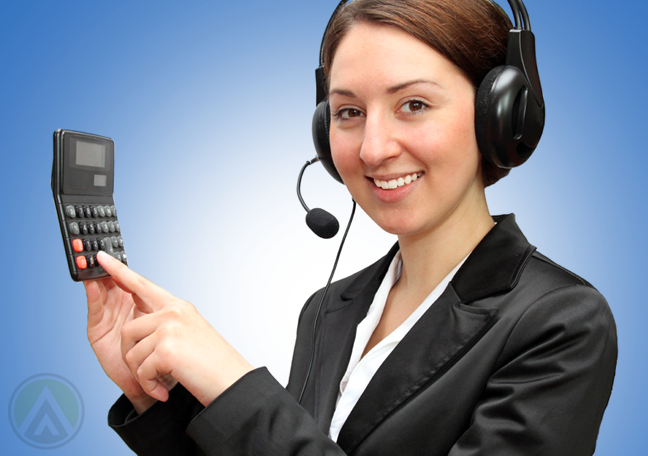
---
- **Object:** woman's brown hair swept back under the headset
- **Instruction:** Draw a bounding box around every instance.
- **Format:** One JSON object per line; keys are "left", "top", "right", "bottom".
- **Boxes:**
{"left": 323, "top": 0, "right": 512, "bottom": 187}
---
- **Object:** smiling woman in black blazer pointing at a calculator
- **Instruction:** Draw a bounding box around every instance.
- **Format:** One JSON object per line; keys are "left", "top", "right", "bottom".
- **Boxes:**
{"left": 86, "top": 0, "right": 616, "bottom": 456}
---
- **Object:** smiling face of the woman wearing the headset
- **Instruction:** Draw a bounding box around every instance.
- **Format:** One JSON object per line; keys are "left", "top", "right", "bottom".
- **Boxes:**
{"left": 329, "top": 22, "right": 485, "bottom": 236}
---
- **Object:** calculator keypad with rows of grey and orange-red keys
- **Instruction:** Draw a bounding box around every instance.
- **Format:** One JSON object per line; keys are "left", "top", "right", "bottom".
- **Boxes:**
{"left": 63, "top": 204, "right": 128, "bottom": 271}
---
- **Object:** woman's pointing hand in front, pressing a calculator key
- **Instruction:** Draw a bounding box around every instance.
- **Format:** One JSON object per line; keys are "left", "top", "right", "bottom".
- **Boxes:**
{"left": 97, "top": 252, "right": 252, "bottom": 406}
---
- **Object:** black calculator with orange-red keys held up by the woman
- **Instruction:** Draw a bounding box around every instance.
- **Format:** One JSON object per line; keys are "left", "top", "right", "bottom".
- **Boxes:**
{"left": 52, "top": 130, "right": 128, "bottom": 282}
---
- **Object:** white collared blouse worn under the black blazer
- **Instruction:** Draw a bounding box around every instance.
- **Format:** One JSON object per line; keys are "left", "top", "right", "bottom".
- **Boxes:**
{"left": 329, "top": 252, "right": 468, "bottom": 441}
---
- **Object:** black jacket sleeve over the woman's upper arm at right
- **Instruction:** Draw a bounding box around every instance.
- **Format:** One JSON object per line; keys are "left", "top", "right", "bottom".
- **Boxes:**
{"left": 449, "top": 285, "right": 617, "bottom": 456}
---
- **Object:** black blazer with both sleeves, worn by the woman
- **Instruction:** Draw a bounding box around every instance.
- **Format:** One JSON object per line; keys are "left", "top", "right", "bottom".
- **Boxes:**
{"left": 109, "top": 215, "right": 617, "bottom": 456}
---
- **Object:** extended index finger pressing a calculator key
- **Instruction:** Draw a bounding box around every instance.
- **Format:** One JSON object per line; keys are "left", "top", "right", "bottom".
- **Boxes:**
{"left": 97, "top": 251, "right": 173, "bottom": 313}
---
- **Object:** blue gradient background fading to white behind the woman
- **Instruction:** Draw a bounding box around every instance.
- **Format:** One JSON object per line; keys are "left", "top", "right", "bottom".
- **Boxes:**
{"left": 0, "top": 0, "right": 648, "bottom": 456}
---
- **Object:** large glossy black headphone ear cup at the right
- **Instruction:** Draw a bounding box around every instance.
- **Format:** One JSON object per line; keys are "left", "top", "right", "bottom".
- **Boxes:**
{"left": 475, "top": 66, "right": 544, "bottom": 169}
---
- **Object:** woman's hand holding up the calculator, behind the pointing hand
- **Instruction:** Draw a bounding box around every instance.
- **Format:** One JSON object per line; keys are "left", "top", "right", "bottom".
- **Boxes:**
{"left": 84, "top": 278, "right": 165, "bottom": 413}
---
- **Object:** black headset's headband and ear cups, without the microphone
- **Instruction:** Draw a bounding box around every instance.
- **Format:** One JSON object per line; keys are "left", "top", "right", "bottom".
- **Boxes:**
{"left": 313, "top": 0, "right": 545, "bottom": 178}
